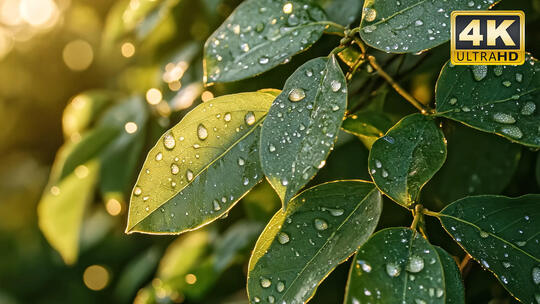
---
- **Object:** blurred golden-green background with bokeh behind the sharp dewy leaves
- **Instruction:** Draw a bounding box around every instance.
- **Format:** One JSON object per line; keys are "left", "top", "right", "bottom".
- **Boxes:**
{"left": 0, "top": 0, "right": 540, "bottom": 304}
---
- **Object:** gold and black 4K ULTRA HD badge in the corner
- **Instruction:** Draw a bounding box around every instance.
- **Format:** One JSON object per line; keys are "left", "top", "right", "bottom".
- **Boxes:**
{"left": 450, "top": 11, "right": 525, "bottom": 65}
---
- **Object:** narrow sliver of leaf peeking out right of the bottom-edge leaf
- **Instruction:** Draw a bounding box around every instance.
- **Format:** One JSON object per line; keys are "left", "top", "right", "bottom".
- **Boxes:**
{"left": 434, "top": 246, "right": 465, "bottom": 304}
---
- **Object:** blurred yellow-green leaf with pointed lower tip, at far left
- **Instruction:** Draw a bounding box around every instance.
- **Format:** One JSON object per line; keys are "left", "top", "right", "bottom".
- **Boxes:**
{"left": 38, "top": 160, "right": 99, "bottom": 264}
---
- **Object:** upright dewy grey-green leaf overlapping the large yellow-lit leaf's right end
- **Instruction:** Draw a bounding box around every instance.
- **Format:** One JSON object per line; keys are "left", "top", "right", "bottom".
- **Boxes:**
{"left": 260, "top": 56, "right": 347, "bottom": 206}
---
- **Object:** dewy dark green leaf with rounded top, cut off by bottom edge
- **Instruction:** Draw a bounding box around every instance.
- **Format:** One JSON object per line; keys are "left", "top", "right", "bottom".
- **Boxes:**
{"left": 345, "top": 228, "right": 448, "bottom": 304}
